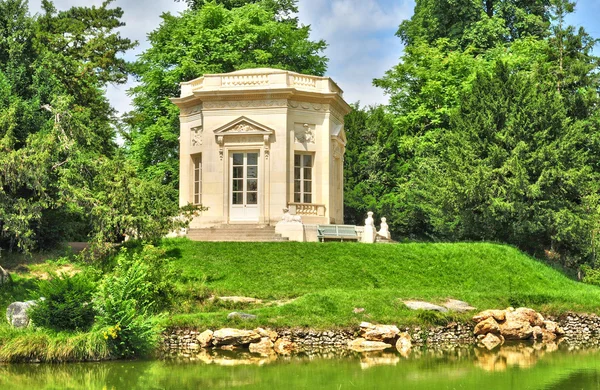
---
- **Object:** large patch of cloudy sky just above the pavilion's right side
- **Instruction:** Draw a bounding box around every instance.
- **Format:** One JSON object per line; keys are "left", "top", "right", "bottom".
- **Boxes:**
{"left": 299, "top": 0, "right": 414, "bottom": 104}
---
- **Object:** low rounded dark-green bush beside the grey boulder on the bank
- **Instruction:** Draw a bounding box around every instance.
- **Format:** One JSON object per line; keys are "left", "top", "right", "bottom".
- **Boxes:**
{"left": 29, "top": 274, "right": 96, "bottom": 332}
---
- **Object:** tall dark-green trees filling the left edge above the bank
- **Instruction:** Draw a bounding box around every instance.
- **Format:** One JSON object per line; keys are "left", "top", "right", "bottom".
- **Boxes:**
{"left": 0, "top": 0, "right": 134, "bottom": 251}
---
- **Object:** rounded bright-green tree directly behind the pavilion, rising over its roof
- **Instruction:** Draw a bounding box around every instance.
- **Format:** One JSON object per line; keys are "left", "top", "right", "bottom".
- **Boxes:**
{"left": 126, "top": 1, "right": 327, "bottom": 188}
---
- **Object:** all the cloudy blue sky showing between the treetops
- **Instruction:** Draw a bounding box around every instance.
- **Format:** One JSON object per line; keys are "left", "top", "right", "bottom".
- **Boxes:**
{"left": 29, "top": 0, "right": 600, "bottom": 112}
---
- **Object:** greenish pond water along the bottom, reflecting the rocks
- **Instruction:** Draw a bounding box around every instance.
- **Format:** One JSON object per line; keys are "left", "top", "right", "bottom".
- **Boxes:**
{"left": 0, "top": 346, "right": 600, "bottom": 390}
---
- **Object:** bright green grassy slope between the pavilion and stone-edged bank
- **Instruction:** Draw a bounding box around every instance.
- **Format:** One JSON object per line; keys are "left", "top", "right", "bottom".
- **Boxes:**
{"left": 163, "top": 239, "right": 600, "bottom": 328}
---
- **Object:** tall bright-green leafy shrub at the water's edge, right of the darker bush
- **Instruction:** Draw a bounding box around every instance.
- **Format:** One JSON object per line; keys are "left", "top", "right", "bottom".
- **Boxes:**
{"left": 94, "top": 245, "right": 173, "bottom": 357}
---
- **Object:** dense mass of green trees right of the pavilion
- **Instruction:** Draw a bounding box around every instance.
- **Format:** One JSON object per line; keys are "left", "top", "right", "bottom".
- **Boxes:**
{"left": 345, "top": 0, "right": 600, "bottom": 269}
